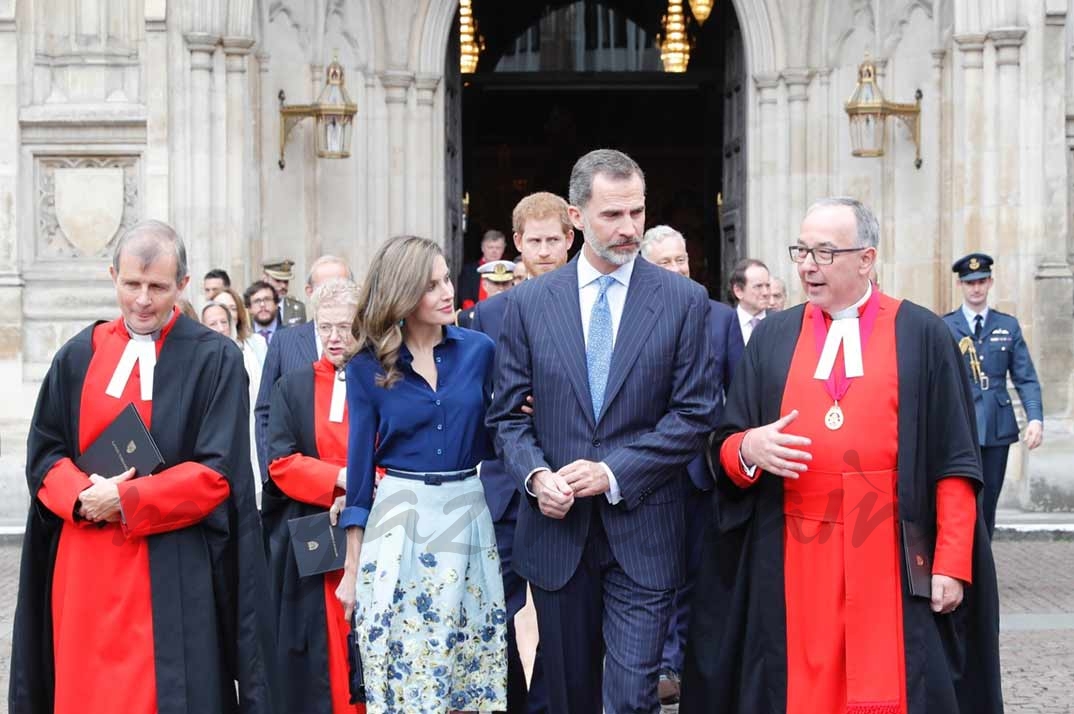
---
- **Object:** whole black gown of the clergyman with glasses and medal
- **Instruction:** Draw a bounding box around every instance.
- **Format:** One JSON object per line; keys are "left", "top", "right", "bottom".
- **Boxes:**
{"left": 679, "top": 301, "right": 1003, "bottom": 714}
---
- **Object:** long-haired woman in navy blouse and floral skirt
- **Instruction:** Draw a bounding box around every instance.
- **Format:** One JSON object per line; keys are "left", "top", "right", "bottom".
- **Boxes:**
{"left": 337, "top": 236, "right": 507, "bottom": 714}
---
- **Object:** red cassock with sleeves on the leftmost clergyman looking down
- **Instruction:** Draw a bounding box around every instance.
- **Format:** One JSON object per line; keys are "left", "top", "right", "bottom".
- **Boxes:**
{"left": 38, "top": 312, "right": 230, "bottom": 714}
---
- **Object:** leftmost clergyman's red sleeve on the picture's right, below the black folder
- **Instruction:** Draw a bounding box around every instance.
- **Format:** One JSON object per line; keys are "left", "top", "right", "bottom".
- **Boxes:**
{"left": 119, "top": 462, "right": 231, "bottom": 537}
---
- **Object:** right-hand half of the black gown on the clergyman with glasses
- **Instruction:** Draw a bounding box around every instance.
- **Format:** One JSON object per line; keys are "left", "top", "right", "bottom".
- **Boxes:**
{"left": 896, "top": 302, "right": 1003, "bottom": 714}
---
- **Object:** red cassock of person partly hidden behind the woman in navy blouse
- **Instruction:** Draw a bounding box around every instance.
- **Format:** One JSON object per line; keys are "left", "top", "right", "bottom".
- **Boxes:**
{"left": 269, "top": 355, "right": 365, "bottom": 714}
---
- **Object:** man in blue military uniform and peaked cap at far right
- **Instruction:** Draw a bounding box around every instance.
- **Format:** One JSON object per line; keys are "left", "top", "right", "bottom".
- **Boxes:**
{"left": 944, "top": 253, "right": 1044, "bottom": 536}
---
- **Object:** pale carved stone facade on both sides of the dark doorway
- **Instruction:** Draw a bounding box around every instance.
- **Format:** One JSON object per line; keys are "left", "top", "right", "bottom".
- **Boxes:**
{"left": 0, "top": 0, "right": 1074, "bottom": 513}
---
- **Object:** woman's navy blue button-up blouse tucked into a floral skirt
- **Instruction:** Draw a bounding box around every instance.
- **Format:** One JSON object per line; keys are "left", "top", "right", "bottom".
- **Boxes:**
{"left": 339, "top": 325, "right": 495, "bottom": 528}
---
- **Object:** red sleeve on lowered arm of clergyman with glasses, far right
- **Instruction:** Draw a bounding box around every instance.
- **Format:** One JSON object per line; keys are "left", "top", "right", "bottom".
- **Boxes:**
{"left": 932, "top": 477, "right": 977, "bottom": 583}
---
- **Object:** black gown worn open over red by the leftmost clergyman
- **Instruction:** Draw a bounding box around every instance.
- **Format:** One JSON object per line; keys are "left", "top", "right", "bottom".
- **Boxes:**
{"left": 8, "top": 315, "right": 280, "bottom": 714}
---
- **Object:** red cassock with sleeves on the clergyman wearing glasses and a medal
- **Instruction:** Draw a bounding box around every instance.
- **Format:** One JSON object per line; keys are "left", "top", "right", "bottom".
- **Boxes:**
{"left": 721, "top": 295, "right": 976, "bottom": 714}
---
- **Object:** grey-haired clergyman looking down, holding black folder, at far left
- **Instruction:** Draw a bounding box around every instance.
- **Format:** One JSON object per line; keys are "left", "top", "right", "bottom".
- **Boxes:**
{"left": 9, "top": 221, "right": 276, "bottom": 714}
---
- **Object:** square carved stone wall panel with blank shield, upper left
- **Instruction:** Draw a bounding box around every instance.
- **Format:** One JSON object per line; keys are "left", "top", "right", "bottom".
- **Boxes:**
{"left": 34, "top": 155, "right": 142, "bottom": 264}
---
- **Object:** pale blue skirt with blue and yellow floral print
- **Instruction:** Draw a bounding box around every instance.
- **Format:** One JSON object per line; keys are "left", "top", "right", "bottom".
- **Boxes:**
{"left": 354, "top": 476, "right": 507, "bottom": 714}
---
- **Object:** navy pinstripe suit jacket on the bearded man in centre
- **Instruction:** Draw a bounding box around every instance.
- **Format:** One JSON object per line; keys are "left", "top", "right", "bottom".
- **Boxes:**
{"left": 489, "top": 258, "right": 720, "bottom": 591}
